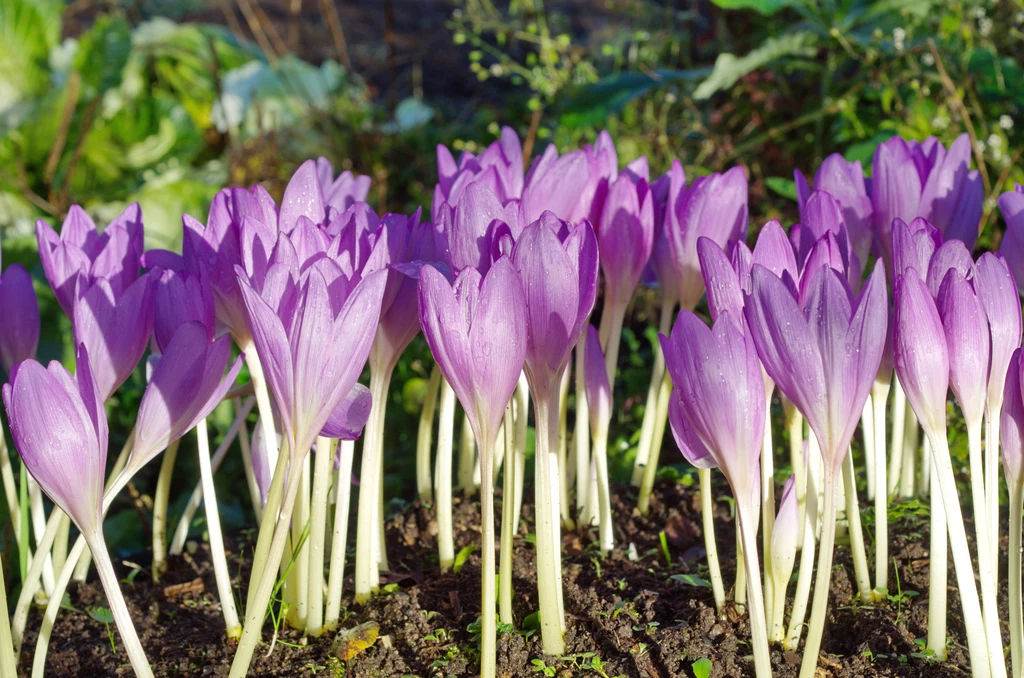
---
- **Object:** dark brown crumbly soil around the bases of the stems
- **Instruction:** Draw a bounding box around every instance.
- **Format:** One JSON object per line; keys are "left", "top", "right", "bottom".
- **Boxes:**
{"left": 22, "top": 483, "right": 983, "bottom": 678}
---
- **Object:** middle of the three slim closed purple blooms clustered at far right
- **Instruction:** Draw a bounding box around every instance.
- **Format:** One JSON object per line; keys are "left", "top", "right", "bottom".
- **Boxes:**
{"left": 936, "top": 268, "right": 990, "bottom": 427}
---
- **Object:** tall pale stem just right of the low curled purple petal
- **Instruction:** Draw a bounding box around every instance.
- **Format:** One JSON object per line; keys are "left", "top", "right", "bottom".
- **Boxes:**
{"left": 355, "top": 365, "right": 389, "bottom": 603}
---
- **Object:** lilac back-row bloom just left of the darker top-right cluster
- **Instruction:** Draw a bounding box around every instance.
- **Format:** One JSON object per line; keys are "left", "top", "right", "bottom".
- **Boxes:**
{"left": 793, "top": 153, "right": 873, "bottom": 261}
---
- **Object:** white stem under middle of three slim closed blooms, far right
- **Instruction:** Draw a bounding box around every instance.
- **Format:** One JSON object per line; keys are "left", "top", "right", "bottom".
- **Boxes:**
{"left": 967, "top": 421, "right": 1006, "bottom": 675}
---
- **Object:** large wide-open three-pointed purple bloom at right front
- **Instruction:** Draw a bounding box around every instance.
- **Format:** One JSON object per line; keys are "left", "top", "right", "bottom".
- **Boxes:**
{"left": 744, "top": 265, "right": 888, "bottom": 472}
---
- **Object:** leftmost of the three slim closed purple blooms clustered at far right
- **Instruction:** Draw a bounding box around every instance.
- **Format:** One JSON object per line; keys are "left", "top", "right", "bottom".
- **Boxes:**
{"left": 893, "top": 268, "right": 949, "bottom": 431}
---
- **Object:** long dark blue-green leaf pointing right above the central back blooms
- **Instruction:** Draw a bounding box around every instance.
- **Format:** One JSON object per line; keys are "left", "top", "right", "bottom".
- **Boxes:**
{"left": 561, "top": 69, "right": 711, "bottom": 127}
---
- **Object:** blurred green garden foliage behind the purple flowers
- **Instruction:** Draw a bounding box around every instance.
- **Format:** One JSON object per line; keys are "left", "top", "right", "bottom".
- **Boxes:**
{"left": 0, "top": 0, "right": 1024, "bottom": 553}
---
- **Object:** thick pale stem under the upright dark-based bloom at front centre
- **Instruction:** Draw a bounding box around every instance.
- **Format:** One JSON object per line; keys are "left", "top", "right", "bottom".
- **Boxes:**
{"left": 534, "top": 394, "right": 565, "bottom": 655}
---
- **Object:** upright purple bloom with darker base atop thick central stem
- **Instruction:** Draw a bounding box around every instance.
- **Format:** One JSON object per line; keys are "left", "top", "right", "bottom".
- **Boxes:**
{"left": 512, "top": 213, "right": 598, "bottom": 400}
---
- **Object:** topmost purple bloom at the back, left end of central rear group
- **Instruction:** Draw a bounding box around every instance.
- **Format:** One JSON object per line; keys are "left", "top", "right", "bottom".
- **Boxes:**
{"left": 431, "top": 127, "right": 523, "bottom": 222}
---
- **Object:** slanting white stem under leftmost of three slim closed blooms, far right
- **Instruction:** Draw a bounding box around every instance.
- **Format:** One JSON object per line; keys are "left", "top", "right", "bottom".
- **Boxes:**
{"left": 928, "top": 427, "right": 991, "bottom": 678}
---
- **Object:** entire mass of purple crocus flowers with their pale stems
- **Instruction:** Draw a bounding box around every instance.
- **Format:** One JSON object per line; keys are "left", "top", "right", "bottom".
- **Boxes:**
{"left": 0, "top": 128, "right": 1024, "bottom": 678}
